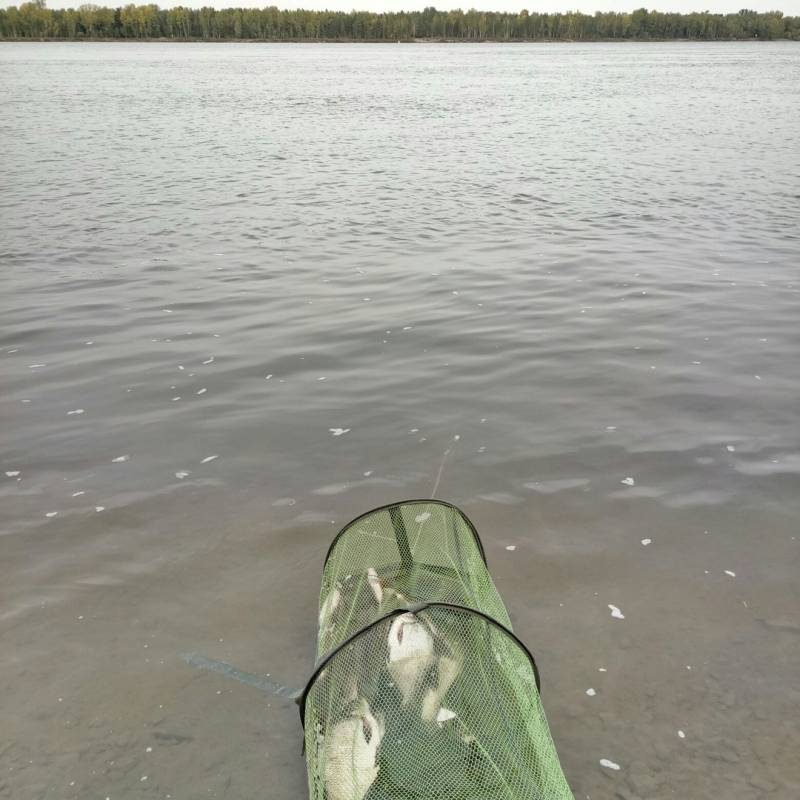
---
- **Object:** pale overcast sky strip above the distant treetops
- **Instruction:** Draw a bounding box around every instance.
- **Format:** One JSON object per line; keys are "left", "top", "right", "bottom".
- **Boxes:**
{"left": 34, "top": 0, "right": 800, "bottom": 16}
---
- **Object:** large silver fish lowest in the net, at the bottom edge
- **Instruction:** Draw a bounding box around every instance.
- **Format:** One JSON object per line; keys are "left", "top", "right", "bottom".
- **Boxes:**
{"left": 324, "top": 698, "right": 384, "bottom": 800}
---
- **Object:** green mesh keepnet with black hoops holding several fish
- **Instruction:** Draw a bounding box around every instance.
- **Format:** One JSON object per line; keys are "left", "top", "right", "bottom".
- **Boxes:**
{"left": 298, "top": 500, "right": 573, "bottom": 800}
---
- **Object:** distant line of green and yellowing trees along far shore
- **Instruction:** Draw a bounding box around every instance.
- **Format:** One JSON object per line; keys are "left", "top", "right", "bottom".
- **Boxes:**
{"left": 0, "top": 0, "right": 800, "bottom": 42}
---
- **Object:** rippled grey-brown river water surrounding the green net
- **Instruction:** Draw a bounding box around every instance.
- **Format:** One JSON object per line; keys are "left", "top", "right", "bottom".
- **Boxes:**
{"left": 0, "top": 43, "right": 800, "bottom": 800}
